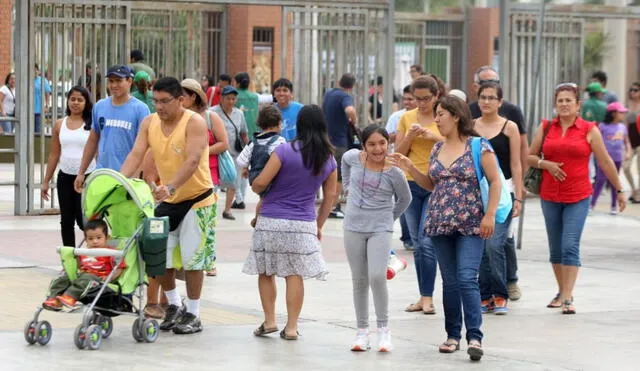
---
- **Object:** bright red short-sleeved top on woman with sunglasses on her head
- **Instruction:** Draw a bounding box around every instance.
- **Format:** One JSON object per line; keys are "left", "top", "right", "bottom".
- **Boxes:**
{"left": 540, "top": 117, "right": 595, "bottom": 203}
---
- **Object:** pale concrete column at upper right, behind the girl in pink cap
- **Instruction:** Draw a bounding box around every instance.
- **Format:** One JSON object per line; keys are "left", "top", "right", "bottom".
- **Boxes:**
{"left": 602, "top": 0, "right": 628, "bottom": 101}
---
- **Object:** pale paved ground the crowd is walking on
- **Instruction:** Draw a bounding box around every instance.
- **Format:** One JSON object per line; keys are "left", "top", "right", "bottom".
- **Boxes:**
{"left": 0, "top": 167, "right": 640, "bottom": 370}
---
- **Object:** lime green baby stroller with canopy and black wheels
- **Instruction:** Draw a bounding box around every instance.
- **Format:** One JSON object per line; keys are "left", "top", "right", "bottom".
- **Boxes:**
{"left": 24, "top": 169, "right": 169, "bottom": 350}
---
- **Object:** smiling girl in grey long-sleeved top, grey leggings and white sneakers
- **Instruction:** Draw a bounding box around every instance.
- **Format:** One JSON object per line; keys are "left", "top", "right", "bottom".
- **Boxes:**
{"left": 342, "top": 125, "right": 411, "bottom": 352}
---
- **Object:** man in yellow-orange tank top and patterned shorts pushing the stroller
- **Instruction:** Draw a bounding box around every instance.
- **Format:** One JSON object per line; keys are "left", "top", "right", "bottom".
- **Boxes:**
{"left": 120, "top": 77, "right": 216, "bottom": 334}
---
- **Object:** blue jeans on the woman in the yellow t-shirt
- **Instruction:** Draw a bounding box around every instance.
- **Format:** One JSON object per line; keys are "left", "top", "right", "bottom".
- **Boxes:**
{"left": 404, "top": 181, "right": 438, "bottom": 297}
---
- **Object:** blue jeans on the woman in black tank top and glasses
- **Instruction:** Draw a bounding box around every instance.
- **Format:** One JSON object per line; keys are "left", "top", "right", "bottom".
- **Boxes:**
{"left": 478, "top": 216, "right": 511, "bottom": 300}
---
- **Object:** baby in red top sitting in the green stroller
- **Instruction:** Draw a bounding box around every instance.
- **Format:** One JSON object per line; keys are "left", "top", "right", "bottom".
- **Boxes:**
{"left": 42, "top": 219, "right": 126, "bottom": 311}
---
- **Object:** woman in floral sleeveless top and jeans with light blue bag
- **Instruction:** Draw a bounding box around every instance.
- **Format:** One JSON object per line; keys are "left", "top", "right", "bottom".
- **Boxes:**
{"left": 391, "top": 96, "right": 502, "bottom": 361}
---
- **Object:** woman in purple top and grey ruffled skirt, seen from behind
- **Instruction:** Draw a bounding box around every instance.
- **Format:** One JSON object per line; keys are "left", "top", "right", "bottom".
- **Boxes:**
{"left": 242, "top": 105, "right": 338, "bottom": 340}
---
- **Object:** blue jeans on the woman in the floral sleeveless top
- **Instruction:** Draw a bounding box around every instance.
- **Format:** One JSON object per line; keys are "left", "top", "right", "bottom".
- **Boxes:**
{"left": 431, "top": 233, "right": 484, "bottom": 342}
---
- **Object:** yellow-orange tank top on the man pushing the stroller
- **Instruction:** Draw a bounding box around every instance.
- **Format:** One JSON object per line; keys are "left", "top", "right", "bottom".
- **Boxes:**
{"left": 148, "top": 110, "right": 216, "bottom": 208}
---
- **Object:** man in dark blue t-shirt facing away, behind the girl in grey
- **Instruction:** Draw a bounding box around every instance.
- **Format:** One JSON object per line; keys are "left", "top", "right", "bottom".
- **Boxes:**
{"left": 322, "top": 73, "right": 358, "bottom": 219}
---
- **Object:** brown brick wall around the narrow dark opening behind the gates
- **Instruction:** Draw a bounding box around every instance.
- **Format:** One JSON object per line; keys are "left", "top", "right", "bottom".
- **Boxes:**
{"left": 226, "top": 5, "right": 282, "bottom": 91}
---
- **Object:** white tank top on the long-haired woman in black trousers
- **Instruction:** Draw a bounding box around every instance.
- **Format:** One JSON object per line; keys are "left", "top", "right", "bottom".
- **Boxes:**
{"left": 58, "top": 117, "right": 96, "bottom": 175}
